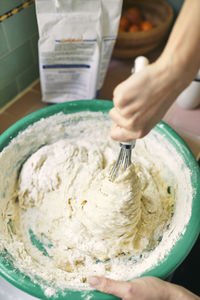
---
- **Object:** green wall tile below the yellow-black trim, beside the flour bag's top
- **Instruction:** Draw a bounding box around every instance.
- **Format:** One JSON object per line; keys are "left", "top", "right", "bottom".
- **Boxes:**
{"left": 3, "top": 4, "right": 38, "bottom": 50}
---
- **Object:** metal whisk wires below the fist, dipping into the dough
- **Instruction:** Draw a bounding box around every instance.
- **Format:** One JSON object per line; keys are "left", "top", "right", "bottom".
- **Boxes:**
{"left": 110, "top": 141, "right": 135, "bottom": 181}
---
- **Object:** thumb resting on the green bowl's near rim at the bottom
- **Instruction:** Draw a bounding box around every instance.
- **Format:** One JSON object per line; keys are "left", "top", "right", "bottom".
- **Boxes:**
{"left": 88, "top": 276, "right": 132, "bottom": 299}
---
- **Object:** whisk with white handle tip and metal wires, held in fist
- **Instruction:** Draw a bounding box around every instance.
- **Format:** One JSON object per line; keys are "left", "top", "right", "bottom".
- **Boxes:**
{"left": 110, "top": 56, "right": 149, "bottom": 181}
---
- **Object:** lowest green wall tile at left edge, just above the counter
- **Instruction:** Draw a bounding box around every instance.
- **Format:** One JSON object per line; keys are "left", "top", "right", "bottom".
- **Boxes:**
{"left": 0, "top": 81, "right": 18, "bottom": 108}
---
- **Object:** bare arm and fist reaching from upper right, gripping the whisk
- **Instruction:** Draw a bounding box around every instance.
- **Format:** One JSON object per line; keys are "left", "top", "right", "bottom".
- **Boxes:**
{"left": 110, "top": 0, "right": 200, "bottom": 142}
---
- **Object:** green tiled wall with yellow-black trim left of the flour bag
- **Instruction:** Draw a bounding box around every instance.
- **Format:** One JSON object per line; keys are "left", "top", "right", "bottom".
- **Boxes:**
{"left": 0, "top": 0, "right": 39, "bottom": 109}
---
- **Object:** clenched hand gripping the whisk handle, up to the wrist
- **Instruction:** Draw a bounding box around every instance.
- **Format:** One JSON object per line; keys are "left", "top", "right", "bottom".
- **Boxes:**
{"left": 110, "top": 59, "right": 182, "bottom": 142}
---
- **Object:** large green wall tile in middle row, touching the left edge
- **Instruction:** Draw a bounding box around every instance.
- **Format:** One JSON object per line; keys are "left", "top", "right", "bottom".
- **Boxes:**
{"left": 0, "top": 41, "right": 34, "bottom": 89}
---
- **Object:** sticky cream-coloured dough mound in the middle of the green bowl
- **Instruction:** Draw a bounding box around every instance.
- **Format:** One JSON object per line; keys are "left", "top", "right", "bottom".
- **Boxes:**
{"left": 17, "top": 139, "right": 173, "bottom": 264}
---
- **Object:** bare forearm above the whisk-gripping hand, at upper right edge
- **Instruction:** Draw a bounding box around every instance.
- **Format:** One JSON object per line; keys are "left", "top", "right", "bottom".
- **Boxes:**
{"left": 160, "top": 0, "right": 200, "bottom": 87}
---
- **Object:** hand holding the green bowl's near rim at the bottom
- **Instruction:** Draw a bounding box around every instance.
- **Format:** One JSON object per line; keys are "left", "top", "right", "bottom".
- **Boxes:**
{"left": 88, "top": 276, "right": 200, "bottom": 300}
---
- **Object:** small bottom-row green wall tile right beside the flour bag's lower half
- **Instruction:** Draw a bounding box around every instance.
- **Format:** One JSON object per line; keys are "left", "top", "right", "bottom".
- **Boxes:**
{"left": 17, "top": 65, "right": 39, "bottom": 92}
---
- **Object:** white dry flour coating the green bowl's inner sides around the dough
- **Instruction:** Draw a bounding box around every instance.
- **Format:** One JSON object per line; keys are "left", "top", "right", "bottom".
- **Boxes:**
{"left": 0, "top": 112, "right": 192, "bottom": 297}
